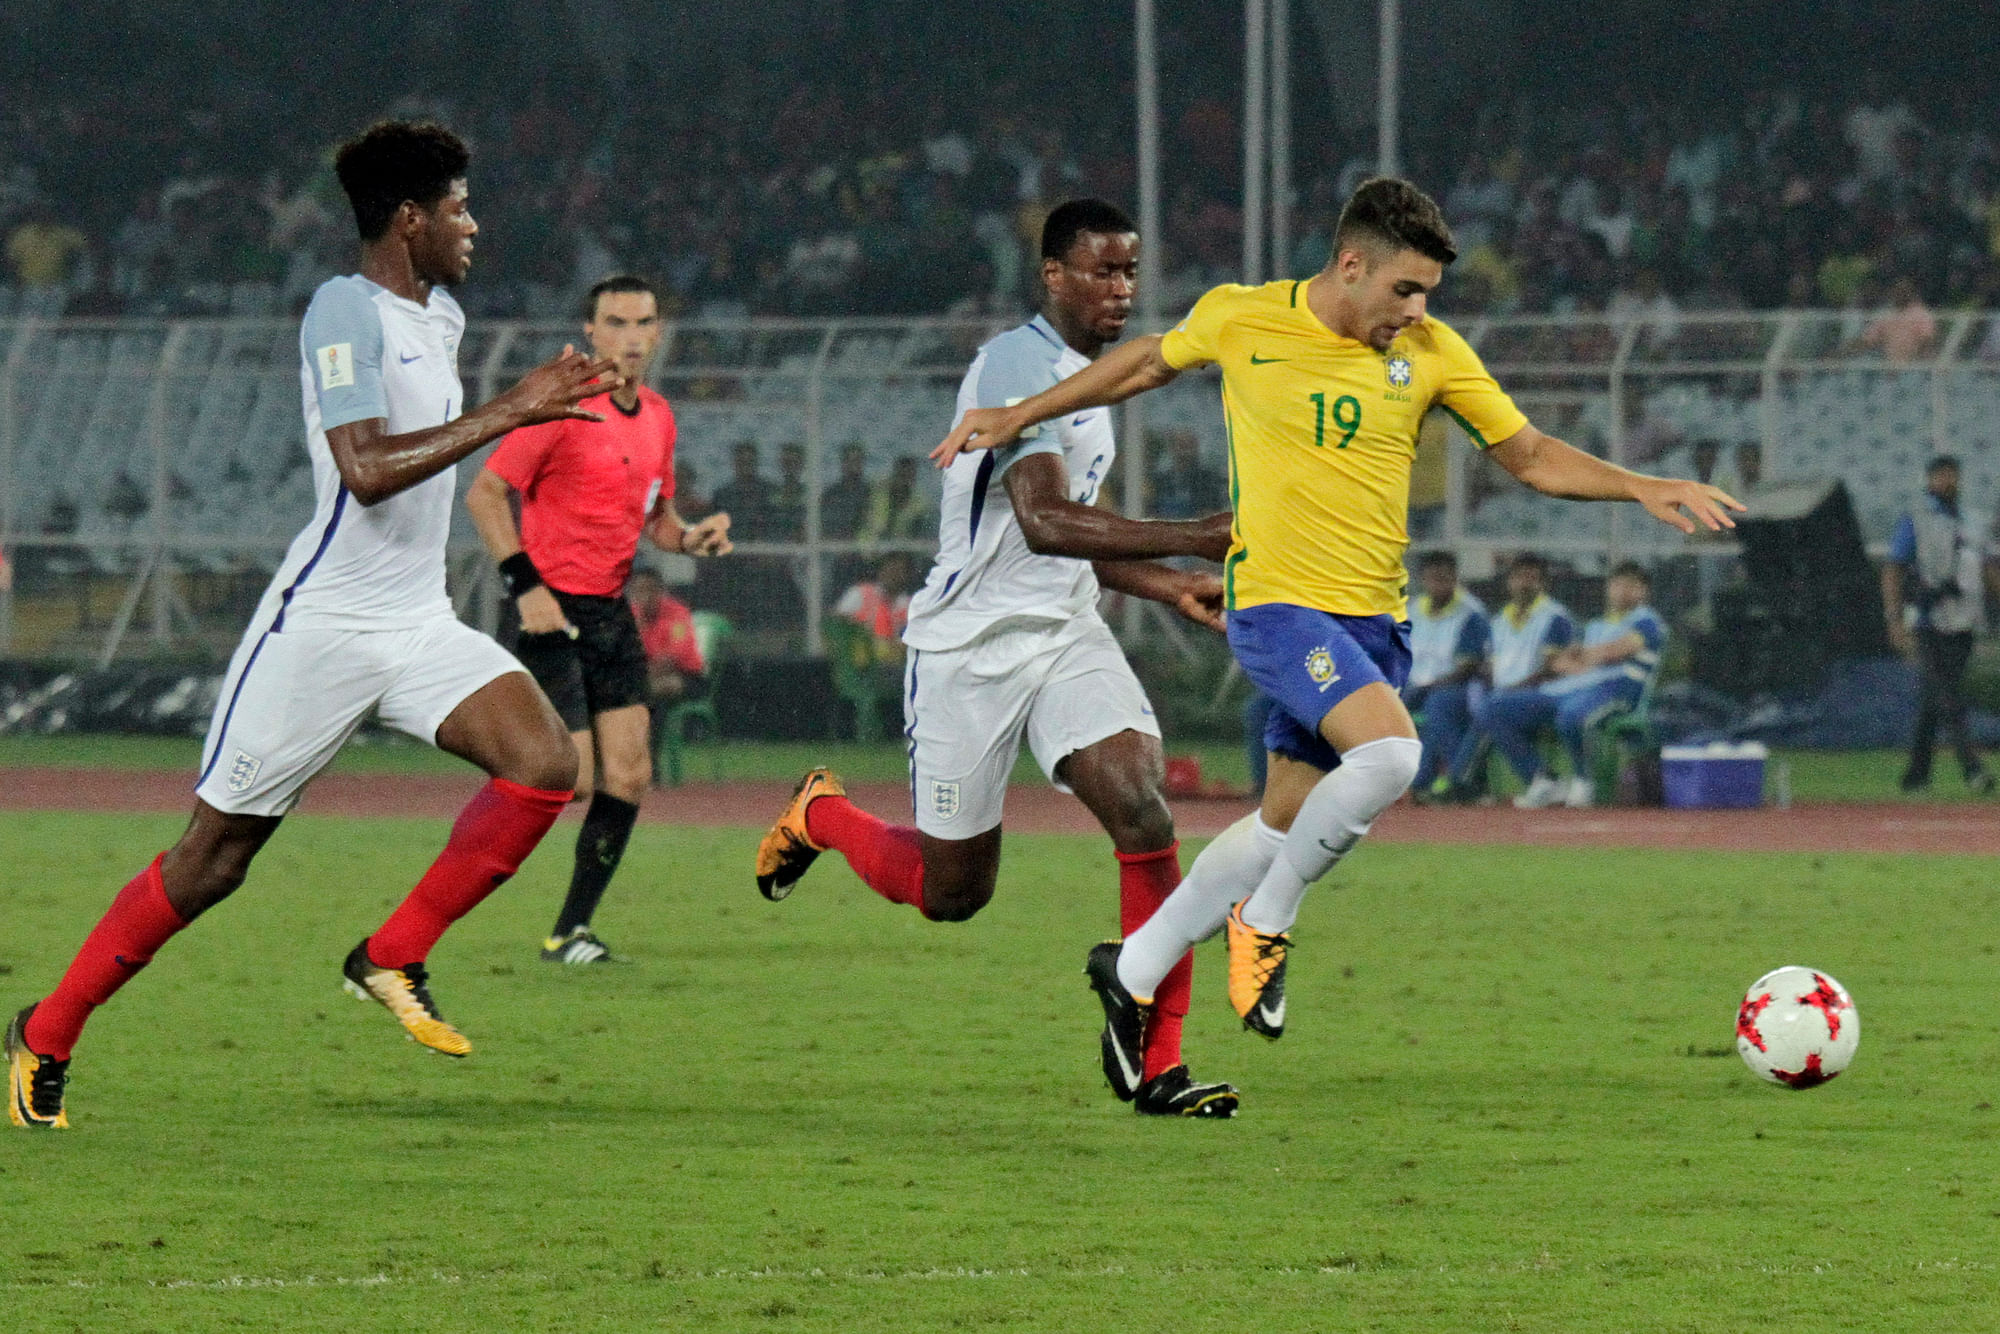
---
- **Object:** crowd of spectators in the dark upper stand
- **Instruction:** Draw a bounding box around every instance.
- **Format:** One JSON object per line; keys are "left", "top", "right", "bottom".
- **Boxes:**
{"left": 11, "top": 22, "right": 2000, "bottom": 328}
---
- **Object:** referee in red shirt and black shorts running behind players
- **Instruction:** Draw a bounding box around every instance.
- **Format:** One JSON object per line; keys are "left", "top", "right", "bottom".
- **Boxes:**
{"left": 466, "top": 274, "right": 730, "bottom": 964}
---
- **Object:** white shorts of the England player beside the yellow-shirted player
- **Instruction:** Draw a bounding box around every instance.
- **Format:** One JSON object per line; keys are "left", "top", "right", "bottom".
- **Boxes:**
{"left": 902, "top": 612, "right": 1160, "bottom": 838}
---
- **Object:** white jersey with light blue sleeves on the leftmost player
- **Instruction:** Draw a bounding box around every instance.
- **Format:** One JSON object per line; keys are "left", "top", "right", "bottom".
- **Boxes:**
{"left": 252, "top": 274, "right": 466, "bottom": 632}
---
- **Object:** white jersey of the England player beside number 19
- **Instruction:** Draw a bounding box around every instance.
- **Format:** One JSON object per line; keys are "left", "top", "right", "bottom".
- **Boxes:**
{"left": 902, "top": 316, "right": 1118, "bottom": 652}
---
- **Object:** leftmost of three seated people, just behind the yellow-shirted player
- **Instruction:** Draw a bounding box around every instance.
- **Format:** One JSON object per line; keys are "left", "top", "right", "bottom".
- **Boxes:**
{"left": 1402, "top": 552, "right": 1492, "bottom": 802}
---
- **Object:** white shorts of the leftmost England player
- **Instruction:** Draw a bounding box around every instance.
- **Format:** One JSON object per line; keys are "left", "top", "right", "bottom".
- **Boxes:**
{"left": 194, "top": 618, "right": 526, "bottom": 816}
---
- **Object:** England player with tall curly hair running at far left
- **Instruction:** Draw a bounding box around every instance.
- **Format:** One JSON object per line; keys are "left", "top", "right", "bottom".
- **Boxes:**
{"left": 6, "top": 122, "right": 612, "bottom": 1128}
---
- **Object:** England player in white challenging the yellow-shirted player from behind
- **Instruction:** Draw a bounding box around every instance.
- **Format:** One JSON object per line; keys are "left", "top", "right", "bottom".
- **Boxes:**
{"left": 756, "top": 200, "right": 1238, "bottom": 1116}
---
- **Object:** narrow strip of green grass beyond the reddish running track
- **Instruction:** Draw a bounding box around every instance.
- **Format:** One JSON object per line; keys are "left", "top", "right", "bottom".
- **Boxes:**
{"left": 0, "top": 736, "right": 1992, "bottom": 802}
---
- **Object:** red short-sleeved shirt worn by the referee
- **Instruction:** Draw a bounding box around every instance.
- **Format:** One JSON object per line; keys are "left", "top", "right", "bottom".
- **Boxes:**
{"left": 486, "top": 388, "right": 674, "bottom": 596}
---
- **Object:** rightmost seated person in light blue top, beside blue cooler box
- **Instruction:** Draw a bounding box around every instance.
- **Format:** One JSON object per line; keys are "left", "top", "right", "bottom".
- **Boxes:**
{"left": 1486, "top": 560, "right": 1666, "bottom": 810}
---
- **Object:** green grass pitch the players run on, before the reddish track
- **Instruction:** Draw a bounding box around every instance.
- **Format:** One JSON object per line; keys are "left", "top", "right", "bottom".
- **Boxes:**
{"left": 0, "top": 814, "right": 2000, "bottom": 1334}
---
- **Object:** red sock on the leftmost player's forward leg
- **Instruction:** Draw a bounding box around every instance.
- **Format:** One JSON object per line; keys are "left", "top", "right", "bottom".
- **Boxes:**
{"left": 368, "top": 778, "right": 570, "bottom": 968}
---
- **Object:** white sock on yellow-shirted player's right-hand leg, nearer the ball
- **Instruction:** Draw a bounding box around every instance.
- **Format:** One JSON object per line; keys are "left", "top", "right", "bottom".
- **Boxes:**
{"left": 1244, "top": 736, "right": 1424, "bottom": 936}
